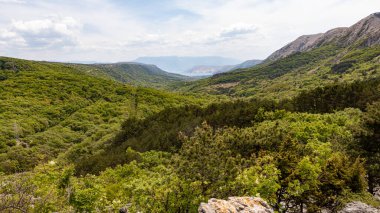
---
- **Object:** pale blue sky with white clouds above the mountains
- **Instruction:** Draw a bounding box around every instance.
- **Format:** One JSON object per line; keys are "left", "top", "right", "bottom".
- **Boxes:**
{"left": 0, "top": 0, "right": 380, "bottom": 62}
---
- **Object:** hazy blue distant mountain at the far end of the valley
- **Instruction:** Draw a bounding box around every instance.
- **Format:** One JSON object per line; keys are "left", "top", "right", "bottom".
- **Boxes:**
{"left": 135, "top": 56, "right": 241, "bottom": 75}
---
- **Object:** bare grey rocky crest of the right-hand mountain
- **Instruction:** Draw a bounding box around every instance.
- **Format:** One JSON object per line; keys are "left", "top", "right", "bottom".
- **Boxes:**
{"left": 266, "top": 13, "right": 380, "bottom": 61}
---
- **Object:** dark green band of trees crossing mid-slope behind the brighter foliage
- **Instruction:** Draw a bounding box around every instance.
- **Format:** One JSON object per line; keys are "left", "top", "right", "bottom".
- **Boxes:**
{"left": 65, "top": 75, "right": 380, "bottom": 174}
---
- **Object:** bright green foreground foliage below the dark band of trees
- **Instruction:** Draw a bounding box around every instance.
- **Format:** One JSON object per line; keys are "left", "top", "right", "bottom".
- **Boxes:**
{"left": 1, "top": 109, "right": 372, "bottom": 212}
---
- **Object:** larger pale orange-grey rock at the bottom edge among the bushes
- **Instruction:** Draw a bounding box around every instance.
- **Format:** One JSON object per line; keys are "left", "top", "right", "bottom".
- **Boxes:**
{"left": 198, "top": 197, "right": 273, "bottom": 213}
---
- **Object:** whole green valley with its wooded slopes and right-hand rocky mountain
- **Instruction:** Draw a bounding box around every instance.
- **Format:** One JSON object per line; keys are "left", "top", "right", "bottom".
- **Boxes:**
{"left": 0, "top": 13, "right": 380, "bottom": 212}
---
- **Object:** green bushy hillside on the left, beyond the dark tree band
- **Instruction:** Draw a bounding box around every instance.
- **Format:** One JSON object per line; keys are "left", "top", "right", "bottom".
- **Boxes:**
{"left": 0, "top": 58, "right": 208, "bottom": 172}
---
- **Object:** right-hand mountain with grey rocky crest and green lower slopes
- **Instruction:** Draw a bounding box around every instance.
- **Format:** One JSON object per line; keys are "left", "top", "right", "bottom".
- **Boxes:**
{"left": 176, "top": 13, "right": 380, "bottom": 98}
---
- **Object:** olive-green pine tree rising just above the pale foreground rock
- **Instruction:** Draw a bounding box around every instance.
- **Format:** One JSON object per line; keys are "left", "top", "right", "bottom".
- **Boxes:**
{"left": 176, "top": 122, "right": 241, "bottom": 196}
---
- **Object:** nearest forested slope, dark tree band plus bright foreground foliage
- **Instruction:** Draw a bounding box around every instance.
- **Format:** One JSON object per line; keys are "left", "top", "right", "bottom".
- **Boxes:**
{"left": 0, "top": 75, "right": 380, "bottom": 212}
